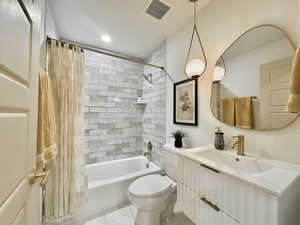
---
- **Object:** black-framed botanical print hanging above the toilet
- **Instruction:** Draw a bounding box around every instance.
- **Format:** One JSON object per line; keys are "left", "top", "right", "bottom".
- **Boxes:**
{"left": 173, "top": 79, "right": 198, "bottom": 126}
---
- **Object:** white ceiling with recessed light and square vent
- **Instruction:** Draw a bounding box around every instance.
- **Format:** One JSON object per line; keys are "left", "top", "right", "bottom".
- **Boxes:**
{"left": 48, "top": 0, "right": 211, "bottom": 59}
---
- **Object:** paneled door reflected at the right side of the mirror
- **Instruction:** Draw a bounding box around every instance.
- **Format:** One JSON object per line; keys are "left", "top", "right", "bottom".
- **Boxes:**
{"left": 260, "top": 57, "right": 296, "bottom": 130}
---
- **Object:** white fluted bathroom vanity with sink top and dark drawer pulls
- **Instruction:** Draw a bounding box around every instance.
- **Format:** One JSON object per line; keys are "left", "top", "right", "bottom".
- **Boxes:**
{"left": 171, "top": 145, "right": 300, "bottom": 225}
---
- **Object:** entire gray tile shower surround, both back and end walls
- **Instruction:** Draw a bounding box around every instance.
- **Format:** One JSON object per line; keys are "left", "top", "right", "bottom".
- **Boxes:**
{"left": 84, "top": 40, "right": 166, "bottom": 165}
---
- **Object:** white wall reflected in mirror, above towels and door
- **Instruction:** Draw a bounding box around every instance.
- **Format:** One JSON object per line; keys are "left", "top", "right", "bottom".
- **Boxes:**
{"left": 222, "top": 39, "right": 293, "bottom": 97}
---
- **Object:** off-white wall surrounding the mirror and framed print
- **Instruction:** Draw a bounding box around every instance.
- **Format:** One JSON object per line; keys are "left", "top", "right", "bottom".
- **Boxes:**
{"left": 167, "top": 0, "right": 300, "bottom": 164}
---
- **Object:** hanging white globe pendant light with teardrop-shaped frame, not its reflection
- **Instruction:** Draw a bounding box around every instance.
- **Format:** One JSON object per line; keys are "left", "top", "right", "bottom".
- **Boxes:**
{"left": 185, "top": 0, "right": 207, "bottom": 78}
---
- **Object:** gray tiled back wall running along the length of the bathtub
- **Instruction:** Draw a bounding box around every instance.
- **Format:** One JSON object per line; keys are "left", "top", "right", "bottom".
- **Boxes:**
{"left": 84, "top": 51, "right": 143, "bottom": 163}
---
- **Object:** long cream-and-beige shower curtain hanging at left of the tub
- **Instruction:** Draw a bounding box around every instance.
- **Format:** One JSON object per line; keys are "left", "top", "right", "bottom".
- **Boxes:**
{"left": 44, "top": 40, "right": 87, "bottom": 222}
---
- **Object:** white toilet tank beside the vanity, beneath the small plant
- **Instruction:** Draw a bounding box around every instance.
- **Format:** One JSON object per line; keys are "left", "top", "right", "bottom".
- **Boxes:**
{"left": 163, "top": 144, "right": 177, "bottom": 181}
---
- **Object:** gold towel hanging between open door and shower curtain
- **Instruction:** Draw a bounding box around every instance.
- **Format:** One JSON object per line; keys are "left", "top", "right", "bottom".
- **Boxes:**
{"left": 37, "top": 71, "right": 57, "bottom": 169}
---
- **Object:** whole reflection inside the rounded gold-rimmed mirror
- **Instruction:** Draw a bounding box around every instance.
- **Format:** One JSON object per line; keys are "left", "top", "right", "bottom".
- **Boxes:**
{"left": 211, "top": 25, "right": 297, "bottom": 130}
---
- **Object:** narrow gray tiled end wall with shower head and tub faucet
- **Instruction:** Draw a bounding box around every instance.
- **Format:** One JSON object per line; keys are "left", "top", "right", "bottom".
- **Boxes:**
{"left": 143, "top": 42, "right": 167, "bottom": 166}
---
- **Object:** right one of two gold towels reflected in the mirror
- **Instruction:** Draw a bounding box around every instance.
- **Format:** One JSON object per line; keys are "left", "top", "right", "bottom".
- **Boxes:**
{"left": 235, "top": 97, "right": 253, "bottom": 129}
